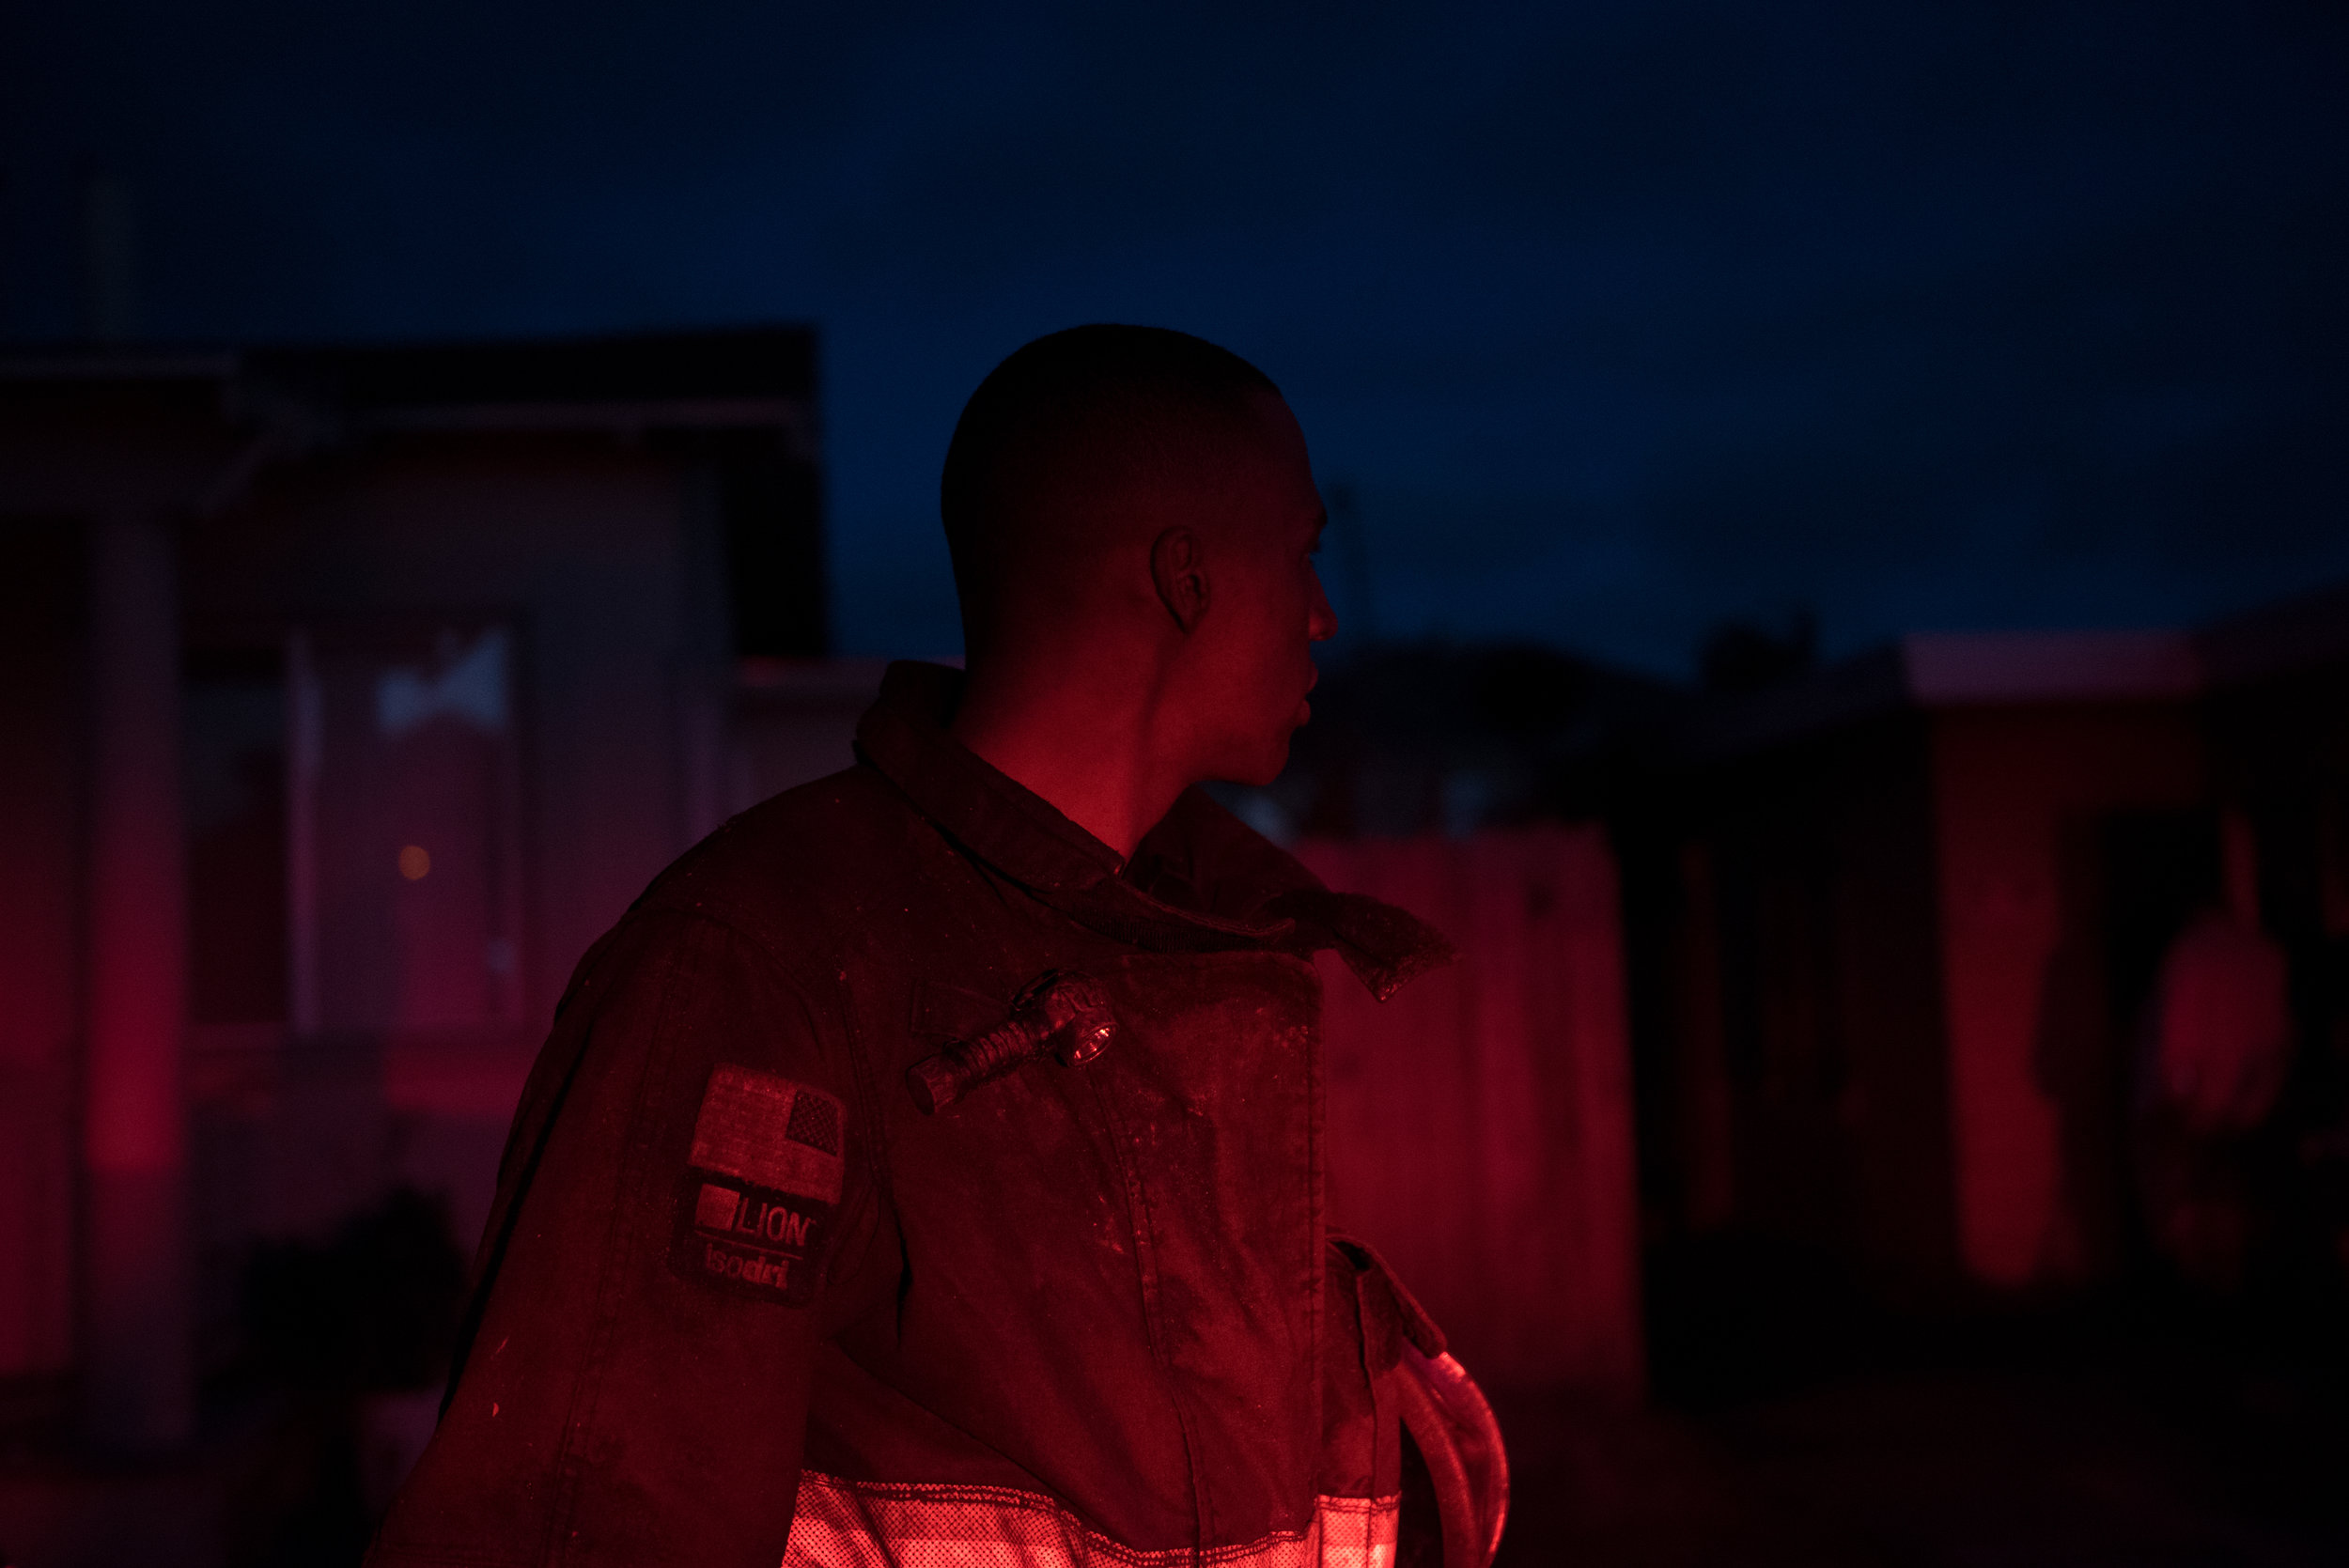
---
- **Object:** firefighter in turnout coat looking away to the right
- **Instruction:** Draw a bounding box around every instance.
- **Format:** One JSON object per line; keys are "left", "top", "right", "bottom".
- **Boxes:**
{"left": 369, "top": 326, "right": 1503, "bottom": 1568}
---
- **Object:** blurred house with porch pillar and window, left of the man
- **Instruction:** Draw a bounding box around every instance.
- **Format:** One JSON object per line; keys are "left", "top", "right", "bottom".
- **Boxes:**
{"left": 0, "top": 329, "right": 879, "bottom": 1449}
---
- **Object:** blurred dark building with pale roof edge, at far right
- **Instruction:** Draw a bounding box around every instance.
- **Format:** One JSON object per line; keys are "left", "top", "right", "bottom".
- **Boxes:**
{"left": 1619, "top": 594, "right": 2349, "bottom": 1305}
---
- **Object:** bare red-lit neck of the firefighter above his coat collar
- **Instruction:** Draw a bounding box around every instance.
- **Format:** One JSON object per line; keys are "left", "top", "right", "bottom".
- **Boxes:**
{"left": 949, "top": 672, "right": 1193, "bottom": 862}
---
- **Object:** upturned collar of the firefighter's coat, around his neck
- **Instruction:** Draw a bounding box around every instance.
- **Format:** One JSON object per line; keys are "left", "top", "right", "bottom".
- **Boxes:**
{"left": 858, "top": 662, "right": 1455, "bottom": 1002}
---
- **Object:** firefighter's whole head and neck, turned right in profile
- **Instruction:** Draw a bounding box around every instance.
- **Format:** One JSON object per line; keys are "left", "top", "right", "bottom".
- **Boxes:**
{"left": 940, "top": 326, "right": 1337, "bottom": 857}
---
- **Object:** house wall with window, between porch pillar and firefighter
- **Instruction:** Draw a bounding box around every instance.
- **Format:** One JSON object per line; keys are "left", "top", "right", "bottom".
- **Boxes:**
{"left": 186, "top": 432, "right": 731, "bottom": 1258}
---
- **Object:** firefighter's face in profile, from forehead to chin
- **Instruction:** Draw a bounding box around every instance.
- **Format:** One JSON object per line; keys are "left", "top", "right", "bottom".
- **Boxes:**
{"left": 1198, "top": 395, "right": 1337, "bottom": 784}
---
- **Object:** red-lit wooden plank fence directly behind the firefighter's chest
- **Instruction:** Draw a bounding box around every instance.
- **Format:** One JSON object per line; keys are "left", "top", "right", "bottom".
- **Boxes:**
{"left": 1299, "top": 826, "right": 1642, "bottom": 1399}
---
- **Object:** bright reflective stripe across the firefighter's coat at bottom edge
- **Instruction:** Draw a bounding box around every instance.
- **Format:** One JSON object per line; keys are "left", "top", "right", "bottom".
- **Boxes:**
{"left": 783, "top": 1469, "right": 1403, "bottom": 1568}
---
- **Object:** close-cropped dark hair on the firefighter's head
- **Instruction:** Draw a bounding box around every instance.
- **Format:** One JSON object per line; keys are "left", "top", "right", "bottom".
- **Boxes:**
{"left": 940, "top": 324, "right": 1281, "bottom": 658}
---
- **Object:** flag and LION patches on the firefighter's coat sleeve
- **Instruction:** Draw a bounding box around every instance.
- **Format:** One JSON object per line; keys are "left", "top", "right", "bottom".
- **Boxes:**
{"left": 670, "top": 1063, "right": 848, "bottom": 1308}
